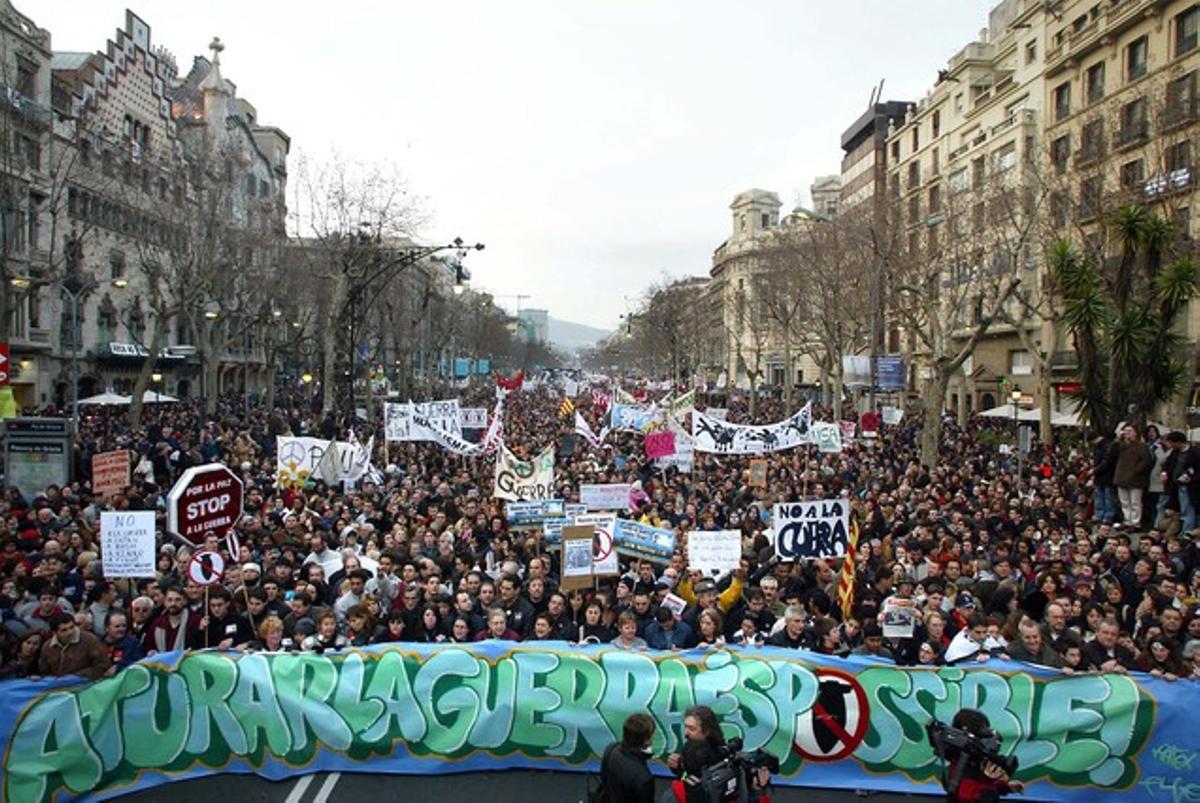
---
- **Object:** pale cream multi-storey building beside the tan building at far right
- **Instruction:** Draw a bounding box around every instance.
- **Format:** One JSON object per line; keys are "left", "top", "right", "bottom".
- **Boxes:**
{"left": 887, "top": 0, "right": 1054, "bottom": 415}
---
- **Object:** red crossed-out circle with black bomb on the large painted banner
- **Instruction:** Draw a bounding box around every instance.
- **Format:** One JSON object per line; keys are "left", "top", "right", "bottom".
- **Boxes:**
{"left": 792, "top": 667, "right": 871, "bottom": 761}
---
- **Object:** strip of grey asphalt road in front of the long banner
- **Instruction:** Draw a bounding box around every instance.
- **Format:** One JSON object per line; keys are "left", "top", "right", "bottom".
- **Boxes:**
{"left": 120, "top": 771, "right": 937, "bottom": 803}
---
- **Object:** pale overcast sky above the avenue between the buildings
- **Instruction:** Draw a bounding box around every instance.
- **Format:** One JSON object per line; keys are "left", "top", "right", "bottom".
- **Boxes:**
{"left": 37, "top": 0, "right": 995, "bottom": 328}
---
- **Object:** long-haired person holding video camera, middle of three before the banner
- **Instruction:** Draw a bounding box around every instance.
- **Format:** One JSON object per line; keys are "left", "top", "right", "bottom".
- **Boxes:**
{"left": 662, "top": 706, "right": 779, "bottom": 803}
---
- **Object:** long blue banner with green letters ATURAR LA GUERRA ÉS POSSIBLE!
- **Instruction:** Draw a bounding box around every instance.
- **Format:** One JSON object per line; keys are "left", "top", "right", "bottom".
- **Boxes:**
{"left": 0, "top": 642, "right": 1200, "bottom": 803}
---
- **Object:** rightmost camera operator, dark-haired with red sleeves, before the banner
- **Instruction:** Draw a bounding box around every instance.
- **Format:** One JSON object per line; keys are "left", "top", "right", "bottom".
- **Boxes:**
{"left": 925, "top": 708, "right": 1025, "bottom": 803}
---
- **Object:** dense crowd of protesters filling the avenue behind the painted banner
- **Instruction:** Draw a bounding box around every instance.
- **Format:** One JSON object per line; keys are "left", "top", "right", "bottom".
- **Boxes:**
{"left": 0, "top": 376, "right": 1200, "bottom": 679}
